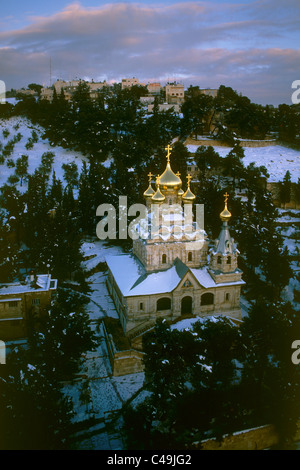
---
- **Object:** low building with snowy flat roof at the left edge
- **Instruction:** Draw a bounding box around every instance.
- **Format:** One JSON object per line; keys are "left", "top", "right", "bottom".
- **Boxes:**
{"left": 0, "top": 274, "right": 57, "bottom": 341}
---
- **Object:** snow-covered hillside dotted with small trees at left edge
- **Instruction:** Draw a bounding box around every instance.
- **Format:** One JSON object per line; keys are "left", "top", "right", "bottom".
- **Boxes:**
{"left": 0, "top": 117, "right": 87, "bottom": 192}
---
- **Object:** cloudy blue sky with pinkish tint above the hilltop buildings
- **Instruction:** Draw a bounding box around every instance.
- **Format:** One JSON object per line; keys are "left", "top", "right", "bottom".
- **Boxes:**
{"left": 0, "top": 0, "right": 300, "bottom": 106}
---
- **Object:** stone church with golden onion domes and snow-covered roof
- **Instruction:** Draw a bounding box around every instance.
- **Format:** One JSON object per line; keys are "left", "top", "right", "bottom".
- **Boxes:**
{"left": 106, "top": 146, "right": 244, "bottom": 375}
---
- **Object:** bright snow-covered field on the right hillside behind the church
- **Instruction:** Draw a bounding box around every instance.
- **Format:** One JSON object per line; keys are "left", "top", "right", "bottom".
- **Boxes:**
{"left": 186, "top": 145, "right": 300, "bottom": 183}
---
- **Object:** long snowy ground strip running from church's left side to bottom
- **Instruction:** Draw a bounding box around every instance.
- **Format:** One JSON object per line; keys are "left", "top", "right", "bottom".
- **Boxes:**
{"left": 60, "top": 238, "right": 146, "bottom": 450}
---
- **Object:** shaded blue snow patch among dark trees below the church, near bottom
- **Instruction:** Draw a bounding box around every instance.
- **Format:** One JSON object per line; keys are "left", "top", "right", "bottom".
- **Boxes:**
{"left": 64, "top": 325, "right": 145, "bottom": 450}
